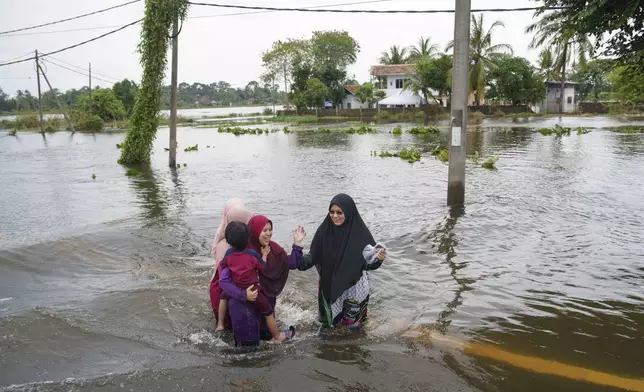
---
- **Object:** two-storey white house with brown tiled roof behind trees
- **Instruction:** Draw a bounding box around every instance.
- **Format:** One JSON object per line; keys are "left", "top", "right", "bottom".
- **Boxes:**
{"left": 371, "top": 64, "right": 447, "bottom": 107}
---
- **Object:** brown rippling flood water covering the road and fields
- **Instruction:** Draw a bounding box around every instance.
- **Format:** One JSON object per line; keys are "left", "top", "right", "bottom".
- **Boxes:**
{"left": 0, "top": 118, "right": 644, "bottom": 391}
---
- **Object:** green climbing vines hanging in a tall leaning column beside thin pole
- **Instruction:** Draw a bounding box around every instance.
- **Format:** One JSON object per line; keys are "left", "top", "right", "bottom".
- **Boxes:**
{"left": 119, "top": 0, "right": 188, "bottom": 164}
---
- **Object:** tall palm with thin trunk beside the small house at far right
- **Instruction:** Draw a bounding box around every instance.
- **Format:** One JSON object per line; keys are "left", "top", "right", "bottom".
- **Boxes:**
{"left": 526, "top": 11, "right": 592, "bottom": 113}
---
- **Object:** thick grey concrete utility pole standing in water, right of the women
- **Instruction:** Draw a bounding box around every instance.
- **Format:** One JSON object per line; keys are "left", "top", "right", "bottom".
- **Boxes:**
{"left": 447, "top": 0, "right": 471, "bottom": 206}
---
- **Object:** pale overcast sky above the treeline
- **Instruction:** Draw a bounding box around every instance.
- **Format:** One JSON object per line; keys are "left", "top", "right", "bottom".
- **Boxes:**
{"left": 0, "top": 0, "right": 537, "bottom": 95}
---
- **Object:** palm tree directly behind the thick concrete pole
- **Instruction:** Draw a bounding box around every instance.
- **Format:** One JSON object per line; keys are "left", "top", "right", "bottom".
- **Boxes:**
{"left": 445, "top": 14, "right": 512, "bottom": 103}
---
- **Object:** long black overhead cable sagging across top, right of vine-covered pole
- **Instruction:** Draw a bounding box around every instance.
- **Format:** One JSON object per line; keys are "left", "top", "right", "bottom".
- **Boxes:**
{"left": 188, "top": 1, "right": 565, "bottom": 14}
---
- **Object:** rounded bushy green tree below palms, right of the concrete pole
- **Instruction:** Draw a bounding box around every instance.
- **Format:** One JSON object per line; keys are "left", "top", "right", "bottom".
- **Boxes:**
{"left": 488, "top": 55, "right": 546, "bottom": 105}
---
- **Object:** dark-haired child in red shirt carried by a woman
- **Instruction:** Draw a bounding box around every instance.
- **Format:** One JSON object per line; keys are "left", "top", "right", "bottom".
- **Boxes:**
{"left": 217, "top": 222, "right": 285, "bottom": 342}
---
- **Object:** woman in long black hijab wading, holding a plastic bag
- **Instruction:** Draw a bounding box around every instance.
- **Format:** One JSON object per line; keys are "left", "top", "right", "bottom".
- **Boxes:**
{"left": 298, "top": 194, "right": 387, "bottom": 328}
